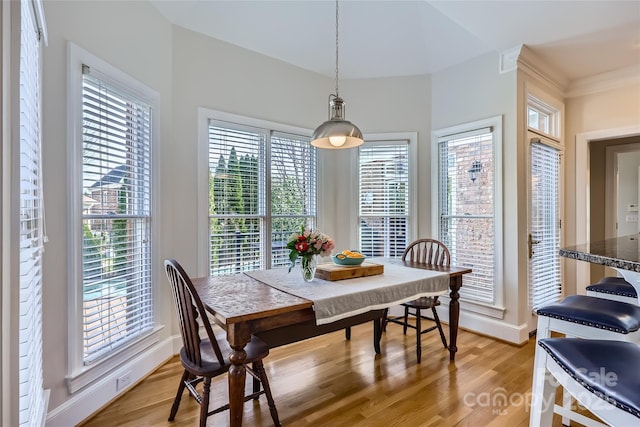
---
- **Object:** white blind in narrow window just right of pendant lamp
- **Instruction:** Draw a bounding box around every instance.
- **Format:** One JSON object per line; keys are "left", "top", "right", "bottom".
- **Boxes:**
{"left": 358, "top": 140, "right": 410, "bottom": 257}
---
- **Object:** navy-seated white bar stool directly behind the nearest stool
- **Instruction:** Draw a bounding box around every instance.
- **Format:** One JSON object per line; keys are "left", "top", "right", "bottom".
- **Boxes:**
{"left": 534, "top": 295, "right": 640, "bottom": 426}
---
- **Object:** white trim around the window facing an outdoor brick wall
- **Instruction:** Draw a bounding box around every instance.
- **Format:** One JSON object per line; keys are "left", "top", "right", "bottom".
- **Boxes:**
{"left": 431, "top": 116, "right": 506, "bottom": 319}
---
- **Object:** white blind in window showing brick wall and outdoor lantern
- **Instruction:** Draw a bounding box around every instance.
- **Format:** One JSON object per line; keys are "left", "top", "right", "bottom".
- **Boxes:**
{"left": 438, "top": 129, "right": 495, "bottom": 304}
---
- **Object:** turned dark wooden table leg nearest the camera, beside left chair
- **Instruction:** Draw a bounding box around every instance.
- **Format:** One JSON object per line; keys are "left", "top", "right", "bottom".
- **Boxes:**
{"left": 227, "top": 324, "right": 251, "bottom": 427}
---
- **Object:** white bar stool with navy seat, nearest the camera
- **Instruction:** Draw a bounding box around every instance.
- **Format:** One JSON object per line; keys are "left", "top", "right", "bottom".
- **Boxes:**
{"left": 529, "top": 338, "right": 640, "bottom": 427}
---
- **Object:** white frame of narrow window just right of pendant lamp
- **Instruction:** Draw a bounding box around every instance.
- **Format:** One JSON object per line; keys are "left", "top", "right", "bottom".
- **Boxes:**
{"left": 352, "top": 132, "right": 418, "bottom": 256}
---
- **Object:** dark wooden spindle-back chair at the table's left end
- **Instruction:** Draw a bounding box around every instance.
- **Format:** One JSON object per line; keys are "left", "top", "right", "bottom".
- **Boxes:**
{"left": 164, "top": 260, "right": 280, "bottom": 427}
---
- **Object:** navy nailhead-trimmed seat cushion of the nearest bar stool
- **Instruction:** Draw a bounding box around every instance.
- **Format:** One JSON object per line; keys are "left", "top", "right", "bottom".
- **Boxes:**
{"left": 538, "top": 338, "right": 640, "bottom": 418}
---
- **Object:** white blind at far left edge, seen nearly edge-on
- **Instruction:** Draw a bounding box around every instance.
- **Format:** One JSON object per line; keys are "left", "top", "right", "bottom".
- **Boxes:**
{"left": 17, "top": 1, "right": 46, "bottom": 426}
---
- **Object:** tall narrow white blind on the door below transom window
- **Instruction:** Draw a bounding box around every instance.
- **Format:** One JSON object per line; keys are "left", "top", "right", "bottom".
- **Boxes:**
{"left": 529, "top": 142, "right": 562, "bottom": 310}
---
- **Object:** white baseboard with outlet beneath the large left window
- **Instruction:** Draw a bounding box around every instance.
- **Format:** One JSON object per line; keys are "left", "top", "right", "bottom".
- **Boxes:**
{"left": 46, "top": 335, "right": 182, "bottom": 427}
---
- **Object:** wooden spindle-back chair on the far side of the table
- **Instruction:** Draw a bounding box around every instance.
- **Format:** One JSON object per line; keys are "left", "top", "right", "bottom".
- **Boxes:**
{"left": 382, "top": 239, "right": 451, "bottom": 363}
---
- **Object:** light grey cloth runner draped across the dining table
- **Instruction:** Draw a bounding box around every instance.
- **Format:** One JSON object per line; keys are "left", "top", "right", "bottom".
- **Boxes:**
{"left": 245, "top": 258, "right": 449, "bottom": 325}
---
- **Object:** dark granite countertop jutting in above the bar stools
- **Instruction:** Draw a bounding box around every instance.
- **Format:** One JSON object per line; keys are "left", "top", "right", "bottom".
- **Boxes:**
{"left": 560, "top": 234, "right": 640, "bottom": 272}
